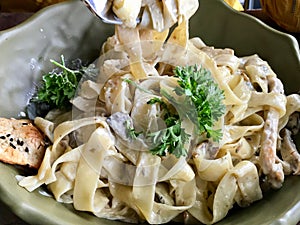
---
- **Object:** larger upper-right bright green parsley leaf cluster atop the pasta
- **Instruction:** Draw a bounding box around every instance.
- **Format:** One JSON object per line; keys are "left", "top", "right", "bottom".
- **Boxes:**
{"left": 174, "top": 65, "right": 225, "bottom": 141}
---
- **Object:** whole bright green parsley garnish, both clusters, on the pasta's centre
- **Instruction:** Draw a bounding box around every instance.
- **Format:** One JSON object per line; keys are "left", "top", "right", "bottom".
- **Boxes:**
{"left": 124, "top": 65, "right": 226, "bottom": 158}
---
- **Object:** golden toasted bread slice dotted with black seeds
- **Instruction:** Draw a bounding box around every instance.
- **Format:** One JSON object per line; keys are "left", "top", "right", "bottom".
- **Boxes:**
{"left": 0, "top": 118, "right": 45, "bottom": 169}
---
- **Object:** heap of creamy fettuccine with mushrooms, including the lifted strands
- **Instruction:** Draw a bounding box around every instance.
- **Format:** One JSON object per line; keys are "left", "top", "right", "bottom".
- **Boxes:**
{"left": 19, "top": 0, "right": 300, "bottom": 224}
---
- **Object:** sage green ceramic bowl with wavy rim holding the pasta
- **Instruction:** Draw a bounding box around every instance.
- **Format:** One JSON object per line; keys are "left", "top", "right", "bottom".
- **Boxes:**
{"left": 0, "top": 0, "right": 300, "bottom": 225}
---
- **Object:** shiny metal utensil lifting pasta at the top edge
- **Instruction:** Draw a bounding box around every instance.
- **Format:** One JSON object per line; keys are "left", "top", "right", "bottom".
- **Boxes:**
{"left": 82, "top": 0, "right": 122, "bottom": 25}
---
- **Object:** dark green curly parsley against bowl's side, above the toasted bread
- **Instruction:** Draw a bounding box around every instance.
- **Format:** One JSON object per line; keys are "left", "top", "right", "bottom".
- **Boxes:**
{"left": 26, "top": 55, "right": 99, "bottom": 119}
